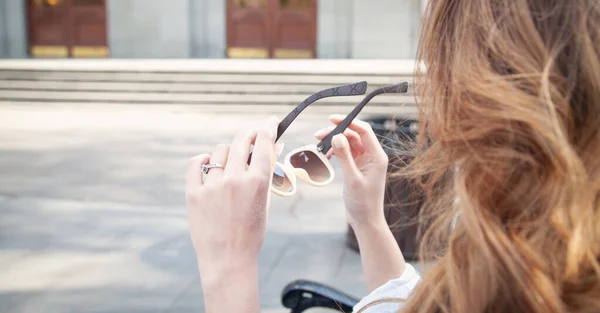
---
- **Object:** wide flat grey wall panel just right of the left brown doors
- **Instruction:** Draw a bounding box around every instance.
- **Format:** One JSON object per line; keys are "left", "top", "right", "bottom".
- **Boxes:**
{"left": 107, "top": 0, "right": 191, "bottom": 58}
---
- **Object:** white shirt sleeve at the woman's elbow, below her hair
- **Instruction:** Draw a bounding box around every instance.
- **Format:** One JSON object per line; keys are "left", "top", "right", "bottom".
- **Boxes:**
{"left": 354, "top": 264, "right": 421, "bottom": 313}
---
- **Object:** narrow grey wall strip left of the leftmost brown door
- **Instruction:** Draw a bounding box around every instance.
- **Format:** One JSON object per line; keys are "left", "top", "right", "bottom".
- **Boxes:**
{"left": 0, "top": 0, "right": 28, "bottom": 58}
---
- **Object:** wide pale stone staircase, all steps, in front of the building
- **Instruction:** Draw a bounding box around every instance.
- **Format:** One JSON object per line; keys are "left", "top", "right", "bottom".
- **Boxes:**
{"left": 0, "top": 60, "right": 415, "bottom": 114}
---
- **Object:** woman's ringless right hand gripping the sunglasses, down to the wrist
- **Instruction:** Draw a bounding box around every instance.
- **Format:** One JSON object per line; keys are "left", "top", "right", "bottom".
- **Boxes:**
{"left": 315, "top": 114, "right": 388, "bottom": 230}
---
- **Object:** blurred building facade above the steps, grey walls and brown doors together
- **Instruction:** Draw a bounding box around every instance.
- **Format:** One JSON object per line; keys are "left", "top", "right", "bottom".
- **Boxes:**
{"left": 0, "top": 0, "right": 425, "bottom": 59}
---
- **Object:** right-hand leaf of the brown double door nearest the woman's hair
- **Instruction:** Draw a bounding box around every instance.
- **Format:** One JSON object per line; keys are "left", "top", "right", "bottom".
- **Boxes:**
{"left": 272, "top": 0, "right": 316, "bottom": 59}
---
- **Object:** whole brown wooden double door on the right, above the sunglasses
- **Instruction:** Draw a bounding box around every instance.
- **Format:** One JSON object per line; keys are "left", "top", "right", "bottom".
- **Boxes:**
{"left": 227, "top": 0, "right": 316, "bottom": 58}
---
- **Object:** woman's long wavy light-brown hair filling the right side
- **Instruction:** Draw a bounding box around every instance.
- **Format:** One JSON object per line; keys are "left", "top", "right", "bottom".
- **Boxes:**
{"left": 400, "top": 0, "right": 600, "bottom": 313}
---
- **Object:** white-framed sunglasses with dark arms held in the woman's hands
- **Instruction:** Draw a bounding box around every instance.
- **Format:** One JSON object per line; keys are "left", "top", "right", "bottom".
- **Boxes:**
{"left": 271, "top": 82, "right": 408, "bottom": 197}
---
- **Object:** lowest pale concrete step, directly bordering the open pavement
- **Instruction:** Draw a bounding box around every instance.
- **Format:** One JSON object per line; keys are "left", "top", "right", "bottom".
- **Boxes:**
{"left": 0, "top": 90, "right": 413, "bottom": 106}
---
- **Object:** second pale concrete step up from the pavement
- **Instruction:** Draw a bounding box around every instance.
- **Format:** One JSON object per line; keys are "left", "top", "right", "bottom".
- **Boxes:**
{"left": 0, "top": 80, "right": 412, "bottom": 96}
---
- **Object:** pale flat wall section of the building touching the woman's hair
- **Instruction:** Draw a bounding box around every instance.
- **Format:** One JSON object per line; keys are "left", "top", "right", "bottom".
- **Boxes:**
{"left": 350, "top": 0, "right": 422, "bottom": 59}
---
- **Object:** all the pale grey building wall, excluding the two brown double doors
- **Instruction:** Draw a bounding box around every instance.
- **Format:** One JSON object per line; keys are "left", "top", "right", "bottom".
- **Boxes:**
{"left": 0, "top": 0, "right": 426, "bottom": 59}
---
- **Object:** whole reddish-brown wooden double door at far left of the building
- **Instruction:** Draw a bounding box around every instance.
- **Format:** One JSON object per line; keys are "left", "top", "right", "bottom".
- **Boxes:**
{"left": 28, "top": 0, "right": 109, "bottom": 58}
